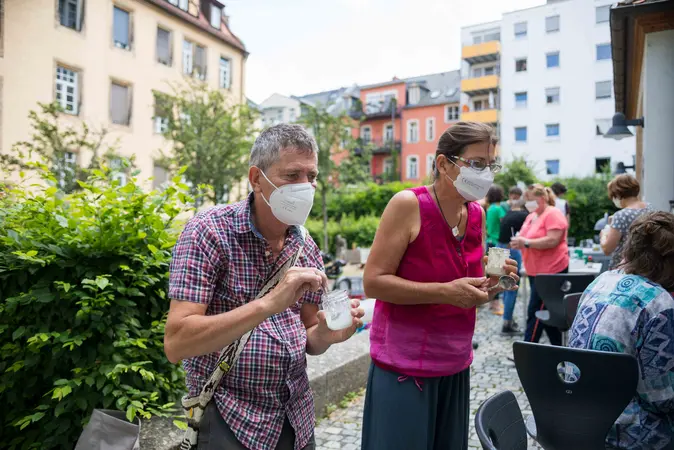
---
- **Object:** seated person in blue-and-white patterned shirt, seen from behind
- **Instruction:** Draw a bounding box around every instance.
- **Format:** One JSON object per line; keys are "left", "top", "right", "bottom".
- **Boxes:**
{"left": 569, "top": 212, "right": 674, "bottom": 450}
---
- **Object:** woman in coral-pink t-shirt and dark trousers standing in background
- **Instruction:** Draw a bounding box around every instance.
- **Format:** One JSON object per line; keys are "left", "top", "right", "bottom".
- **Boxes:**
{"left": 510, "top": 184, "right": 569, "bottom": 345}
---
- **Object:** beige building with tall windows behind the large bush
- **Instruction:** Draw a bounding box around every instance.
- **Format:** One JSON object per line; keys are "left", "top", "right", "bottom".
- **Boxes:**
{"left": 0, "top": 0, "right": 247, "bottom": 189}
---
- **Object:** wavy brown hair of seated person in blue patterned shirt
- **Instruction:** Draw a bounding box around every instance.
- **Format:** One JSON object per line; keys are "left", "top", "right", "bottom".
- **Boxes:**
{"left": 621, "top": 211, "right": 674, "bottom": 292}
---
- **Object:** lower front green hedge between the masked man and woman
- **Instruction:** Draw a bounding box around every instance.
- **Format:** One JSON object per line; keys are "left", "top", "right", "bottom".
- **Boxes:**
{"left": 306, "top": 215, "right": 379, "bottom": 253}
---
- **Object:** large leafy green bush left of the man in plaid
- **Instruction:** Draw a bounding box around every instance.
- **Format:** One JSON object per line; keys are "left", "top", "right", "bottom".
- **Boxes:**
{"left": 0, "top": 163, "right": 191, "bottom": 449}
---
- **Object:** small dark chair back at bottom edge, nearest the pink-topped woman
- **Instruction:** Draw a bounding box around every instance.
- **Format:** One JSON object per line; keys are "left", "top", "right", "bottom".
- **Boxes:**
{"left": 475, "top": 391, "right": 527, "bottom": 450}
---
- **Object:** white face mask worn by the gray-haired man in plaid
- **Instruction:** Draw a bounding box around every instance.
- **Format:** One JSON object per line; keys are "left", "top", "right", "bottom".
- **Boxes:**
{"left": 260, "top": 170, "right": 316, "bottom": 225}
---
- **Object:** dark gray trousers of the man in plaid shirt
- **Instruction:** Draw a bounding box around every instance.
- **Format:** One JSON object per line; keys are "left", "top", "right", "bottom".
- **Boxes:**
{"left": 197, "top": 401, "right": 316, "bottom": 450}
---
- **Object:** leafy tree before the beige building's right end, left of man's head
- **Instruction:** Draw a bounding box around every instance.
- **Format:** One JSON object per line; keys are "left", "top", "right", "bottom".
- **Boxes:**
{"left": 155, "top": 82, "right": 256, "bottom": 204}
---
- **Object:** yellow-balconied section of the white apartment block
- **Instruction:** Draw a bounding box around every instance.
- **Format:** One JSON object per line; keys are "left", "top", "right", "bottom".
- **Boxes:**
{"left": 461, "top": 22, "right": 501, "bottom": 134}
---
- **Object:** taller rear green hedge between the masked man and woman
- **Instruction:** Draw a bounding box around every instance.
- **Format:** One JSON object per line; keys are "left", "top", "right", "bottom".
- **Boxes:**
{"left": 311, "top": 182, "right": 414, "bottom": 221}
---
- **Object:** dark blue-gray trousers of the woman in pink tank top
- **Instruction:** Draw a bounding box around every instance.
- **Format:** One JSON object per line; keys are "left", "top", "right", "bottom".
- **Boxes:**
{"left": 362, "top": 364, "right": 470, "bottom": 450}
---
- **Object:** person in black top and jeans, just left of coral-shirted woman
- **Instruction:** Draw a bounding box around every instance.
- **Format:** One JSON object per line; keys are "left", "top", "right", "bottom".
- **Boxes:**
{"left": 498, "top": 193, "right": 529, "bottom": 335}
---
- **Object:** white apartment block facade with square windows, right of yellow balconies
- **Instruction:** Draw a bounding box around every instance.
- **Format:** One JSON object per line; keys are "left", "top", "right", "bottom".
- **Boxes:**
{"left": 500, "top": 0, "right": 635, "bottom": 178}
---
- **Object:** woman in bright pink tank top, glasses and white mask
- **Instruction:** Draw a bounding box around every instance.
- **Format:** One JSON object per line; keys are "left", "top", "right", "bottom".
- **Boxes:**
{"left": 362, "top": 122, "right": 517, "bottom": 450}
